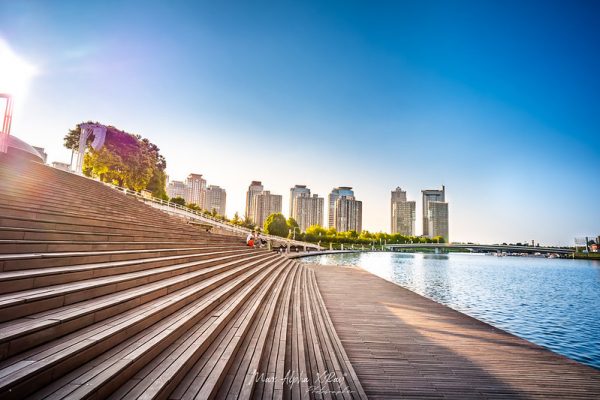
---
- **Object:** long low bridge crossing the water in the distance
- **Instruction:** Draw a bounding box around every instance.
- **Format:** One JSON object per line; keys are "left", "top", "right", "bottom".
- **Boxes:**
{"left": 385, "top": 243, "right": 575, "bottom": 254}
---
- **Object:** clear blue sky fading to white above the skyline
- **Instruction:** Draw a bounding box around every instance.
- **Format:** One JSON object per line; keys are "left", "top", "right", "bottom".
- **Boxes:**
{"left": 0, "top": 0, "right": 600, "bottom": 245}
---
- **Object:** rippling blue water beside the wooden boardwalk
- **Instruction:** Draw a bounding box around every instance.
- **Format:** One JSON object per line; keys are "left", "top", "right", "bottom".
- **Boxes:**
{"left": 302, "top": 253, "right": 600, "bottom": 369}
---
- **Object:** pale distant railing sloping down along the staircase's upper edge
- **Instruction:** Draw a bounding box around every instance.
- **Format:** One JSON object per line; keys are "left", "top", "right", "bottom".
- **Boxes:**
{"left": 54, "top": 166, "right": 322, "bottom": 250}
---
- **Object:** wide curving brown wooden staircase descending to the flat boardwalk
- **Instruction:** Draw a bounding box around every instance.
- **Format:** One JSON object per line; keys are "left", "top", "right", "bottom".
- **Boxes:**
{"left": 0, "top": 155, "right": 366, "bottom": 399}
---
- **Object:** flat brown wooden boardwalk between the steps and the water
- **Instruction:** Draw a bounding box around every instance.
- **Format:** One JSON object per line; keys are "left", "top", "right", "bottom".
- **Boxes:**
{"left": 313, "top": 266, "right": 600, "bottom": 400}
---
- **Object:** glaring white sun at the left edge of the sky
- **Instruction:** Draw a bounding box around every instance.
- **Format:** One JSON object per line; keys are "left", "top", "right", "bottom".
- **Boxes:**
{"left": 0, "top": 39, "right": 37, "bottom": 101}
